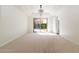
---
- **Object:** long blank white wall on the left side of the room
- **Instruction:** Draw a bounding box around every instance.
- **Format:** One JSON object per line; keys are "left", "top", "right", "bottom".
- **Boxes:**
{"left": 0, "top": 6, "right": 27, "bottom": 46}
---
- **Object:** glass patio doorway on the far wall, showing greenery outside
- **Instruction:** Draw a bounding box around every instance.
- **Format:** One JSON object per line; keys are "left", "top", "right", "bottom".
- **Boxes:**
{"left": 33, "top": 18, "right": 48, "bottom": 33}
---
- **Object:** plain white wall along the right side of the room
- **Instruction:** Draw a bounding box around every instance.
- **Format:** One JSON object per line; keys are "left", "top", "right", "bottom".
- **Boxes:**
{"left": 58, "top": 6, "right": 79, "bottom": 44}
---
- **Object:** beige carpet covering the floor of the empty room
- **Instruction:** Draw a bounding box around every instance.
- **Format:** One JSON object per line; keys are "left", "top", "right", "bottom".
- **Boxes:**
{"left": 0, "top": 33, "right": 79, "bottom": 53}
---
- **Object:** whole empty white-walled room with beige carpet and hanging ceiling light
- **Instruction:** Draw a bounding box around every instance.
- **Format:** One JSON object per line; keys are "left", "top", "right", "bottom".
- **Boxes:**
{"left": 0, "top": 5, "right": 79, "bottom": 53}
